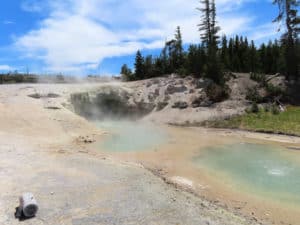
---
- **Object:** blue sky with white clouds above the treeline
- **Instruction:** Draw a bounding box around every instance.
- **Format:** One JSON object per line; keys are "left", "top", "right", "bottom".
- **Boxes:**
{"left": 0, "top": 0, "right": 278, "bottom": 75}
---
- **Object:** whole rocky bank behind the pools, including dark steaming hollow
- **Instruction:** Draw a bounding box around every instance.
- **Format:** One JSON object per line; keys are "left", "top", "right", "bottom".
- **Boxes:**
{"left": 71, "top": 74, "right": 258, "bottom": 125}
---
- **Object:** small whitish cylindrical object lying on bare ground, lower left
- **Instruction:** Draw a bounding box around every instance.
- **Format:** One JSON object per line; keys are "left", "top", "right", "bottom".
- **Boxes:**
{"left": 20, "top": 193, "right": 39, "bottom": 218}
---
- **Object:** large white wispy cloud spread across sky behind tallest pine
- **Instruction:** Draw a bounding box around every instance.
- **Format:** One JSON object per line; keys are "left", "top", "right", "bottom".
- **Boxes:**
{"left": 15, "top": 0, "right": 268, "bottom": 73}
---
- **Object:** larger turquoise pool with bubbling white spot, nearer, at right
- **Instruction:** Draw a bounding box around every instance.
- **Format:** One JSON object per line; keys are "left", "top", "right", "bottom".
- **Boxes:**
{"left": 194, "top": 143, "right": 300, "bottom": 205}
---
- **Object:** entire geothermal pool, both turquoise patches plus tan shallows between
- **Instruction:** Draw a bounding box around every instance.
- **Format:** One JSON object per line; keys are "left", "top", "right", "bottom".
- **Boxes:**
{"left": 93, "top": 120, "right": 300, "bottom": 218}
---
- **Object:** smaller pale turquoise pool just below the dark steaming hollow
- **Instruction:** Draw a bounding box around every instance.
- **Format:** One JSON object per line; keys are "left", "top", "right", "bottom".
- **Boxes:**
{"left": 94, "top": 120, "right": 168, "bottom": 152}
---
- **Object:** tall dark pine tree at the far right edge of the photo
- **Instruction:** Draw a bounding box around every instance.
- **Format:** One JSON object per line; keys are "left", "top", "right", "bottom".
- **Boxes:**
{"left": 273, "top": 0, "right": 300, "bottom": 79}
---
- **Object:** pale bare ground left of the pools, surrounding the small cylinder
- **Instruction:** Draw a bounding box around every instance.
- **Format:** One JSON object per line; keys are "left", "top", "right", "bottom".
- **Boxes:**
{"left": 0, "top": 79, "right": 300, "bottom": 225}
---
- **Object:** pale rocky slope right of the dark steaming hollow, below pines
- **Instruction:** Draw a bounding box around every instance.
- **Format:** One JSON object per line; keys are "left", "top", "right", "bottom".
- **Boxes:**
{"left": 129, "top": 75, "right": 256, "bottom": 125}
